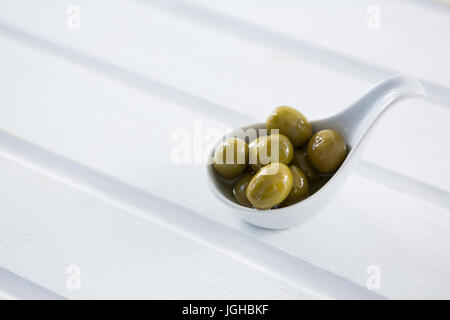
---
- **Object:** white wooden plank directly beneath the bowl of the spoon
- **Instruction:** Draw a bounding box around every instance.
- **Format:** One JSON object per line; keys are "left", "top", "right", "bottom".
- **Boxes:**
{"left": 0, "top": 30, "right": 450, "bottom": 298}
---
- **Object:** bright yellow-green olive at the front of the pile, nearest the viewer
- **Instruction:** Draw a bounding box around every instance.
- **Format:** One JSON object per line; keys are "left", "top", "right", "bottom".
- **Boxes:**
{"left": 247, "top": 162, "right": 293, "bottom": 209}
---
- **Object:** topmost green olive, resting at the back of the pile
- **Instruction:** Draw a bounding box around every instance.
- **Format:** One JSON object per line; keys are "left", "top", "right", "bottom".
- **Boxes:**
{"left": 267, "top": 106, "right": 312, "bottom": 147}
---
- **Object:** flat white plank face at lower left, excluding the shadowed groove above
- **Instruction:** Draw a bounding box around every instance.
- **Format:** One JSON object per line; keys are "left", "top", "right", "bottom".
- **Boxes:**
{"left": 0, "top": 157, "right": 310, "bottom": 299}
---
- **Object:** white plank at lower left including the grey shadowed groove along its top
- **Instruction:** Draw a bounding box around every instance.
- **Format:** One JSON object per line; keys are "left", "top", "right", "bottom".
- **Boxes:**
{"left": 0, "top": 133, "right": 381, "bottom": 299}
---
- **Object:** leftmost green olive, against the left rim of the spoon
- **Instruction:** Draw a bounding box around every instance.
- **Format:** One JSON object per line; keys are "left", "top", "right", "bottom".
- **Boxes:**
{"left": 213, "top": 138, "right": 248, "bottom": 179}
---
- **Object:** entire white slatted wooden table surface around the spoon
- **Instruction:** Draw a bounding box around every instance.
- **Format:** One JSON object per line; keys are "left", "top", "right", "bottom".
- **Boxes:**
{"left": 0, "top": 0, "right": 450, "bottom": 299}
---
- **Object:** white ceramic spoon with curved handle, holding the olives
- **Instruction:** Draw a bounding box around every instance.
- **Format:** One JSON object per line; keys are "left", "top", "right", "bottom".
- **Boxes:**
{"left": 207, "top": 76, "right": 425, "bottom": 229}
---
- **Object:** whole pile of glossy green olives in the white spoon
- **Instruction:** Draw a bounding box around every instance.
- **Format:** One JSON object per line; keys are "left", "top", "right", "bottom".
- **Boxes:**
{"left": 213, "top": 106, "right": 347, "bottom": 210}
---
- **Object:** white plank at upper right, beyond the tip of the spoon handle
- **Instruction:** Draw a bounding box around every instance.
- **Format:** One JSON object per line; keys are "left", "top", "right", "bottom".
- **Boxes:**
{"left": 176, "top": 0, "right": 450, "bottom": 105}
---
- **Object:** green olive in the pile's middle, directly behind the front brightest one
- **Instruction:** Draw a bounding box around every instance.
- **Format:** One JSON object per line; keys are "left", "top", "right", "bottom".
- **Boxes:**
{"left": 249, "top": 134, "right": 294, "bottom": 172}
